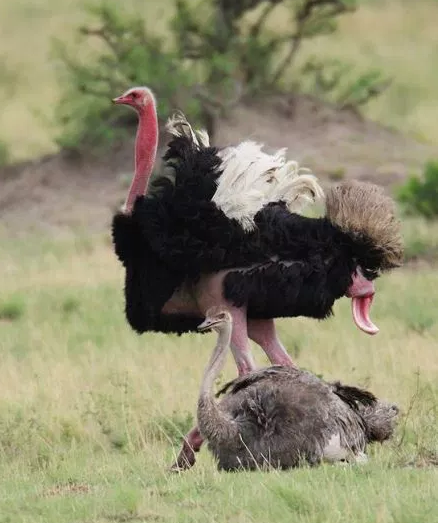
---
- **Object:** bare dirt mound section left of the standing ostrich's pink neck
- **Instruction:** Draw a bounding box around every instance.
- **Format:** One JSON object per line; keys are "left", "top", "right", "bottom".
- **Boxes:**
{"left": 0, "top": 144, "right": 133, "bottom": 232}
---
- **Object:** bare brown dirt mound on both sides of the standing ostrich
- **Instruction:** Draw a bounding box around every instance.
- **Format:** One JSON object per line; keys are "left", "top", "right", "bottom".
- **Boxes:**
{"left": 0, "top": 96, "right": 438, "bottom": 233}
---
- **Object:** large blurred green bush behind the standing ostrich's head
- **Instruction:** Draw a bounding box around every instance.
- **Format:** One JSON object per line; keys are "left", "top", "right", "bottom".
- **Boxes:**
{"left": 55, "top": 0, "right": 386, "bottom": 150}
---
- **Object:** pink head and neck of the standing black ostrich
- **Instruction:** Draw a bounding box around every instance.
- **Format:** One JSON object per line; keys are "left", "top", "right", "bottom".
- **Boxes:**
{"left": 113, "top": 87, "right": 158, "bottom": 213}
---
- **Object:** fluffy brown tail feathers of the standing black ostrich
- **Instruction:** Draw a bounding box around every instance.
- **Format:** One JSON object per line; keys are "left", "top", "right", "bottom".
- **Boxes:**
{"left": 326, "top": 181, "right": 403, "bottom": 270}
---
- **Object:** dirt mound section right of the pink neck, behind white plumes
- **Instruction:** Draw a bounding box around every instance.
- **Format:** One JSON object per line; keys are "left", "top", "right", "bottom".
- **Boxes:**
{"left": 218, "top": 96, "right": 438, "bottom": 186}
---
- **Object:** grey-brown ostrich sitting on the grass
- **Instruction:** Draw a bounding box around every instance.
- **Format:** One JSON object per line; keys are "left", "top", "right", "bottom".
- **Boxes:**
{"left": 198, "top": 307, "right": 398, "bottom": 471}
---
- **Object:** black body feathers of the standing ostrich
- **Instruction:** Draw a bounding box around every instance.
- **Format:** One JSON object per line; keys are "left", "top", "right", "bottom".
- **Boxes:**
{"left": 113, "top": 133, "right": 386, "bottom": 333}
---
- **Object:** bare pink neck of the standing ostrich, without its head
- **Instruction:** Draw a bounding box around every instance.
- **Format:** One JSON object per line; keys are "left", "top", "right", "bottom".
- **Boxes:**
{"left": 125, "top": 100, "right": 158, "bottom": 213}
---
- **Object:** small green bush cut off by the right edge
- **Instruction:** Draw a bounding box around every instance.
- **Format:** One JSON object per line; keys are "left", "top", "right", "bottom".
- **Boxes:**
{"left": 398, "top": 161, "right": 438, "bottom": 220}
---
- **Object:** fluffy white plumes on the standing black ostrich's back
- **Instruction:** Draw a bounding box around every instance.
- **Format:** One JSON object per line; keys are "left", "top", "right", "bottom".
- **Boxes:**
{"left": 213, "top": 141, "right": 324, "bottom": 231}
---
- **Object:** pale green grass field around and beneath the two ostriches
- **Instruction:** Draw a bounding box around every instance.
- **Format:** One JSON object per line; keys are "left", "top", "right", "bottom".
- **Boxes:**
{"left": 0, "top": 220, "right": 438, "bottom": 523}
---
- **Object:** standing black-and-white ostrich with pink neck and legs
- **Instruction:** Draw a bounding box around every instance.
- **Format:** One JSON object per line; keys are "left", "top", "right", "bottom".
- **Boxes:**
{"left": 113, "top": 87, "right": 403, "bottom": 468}
